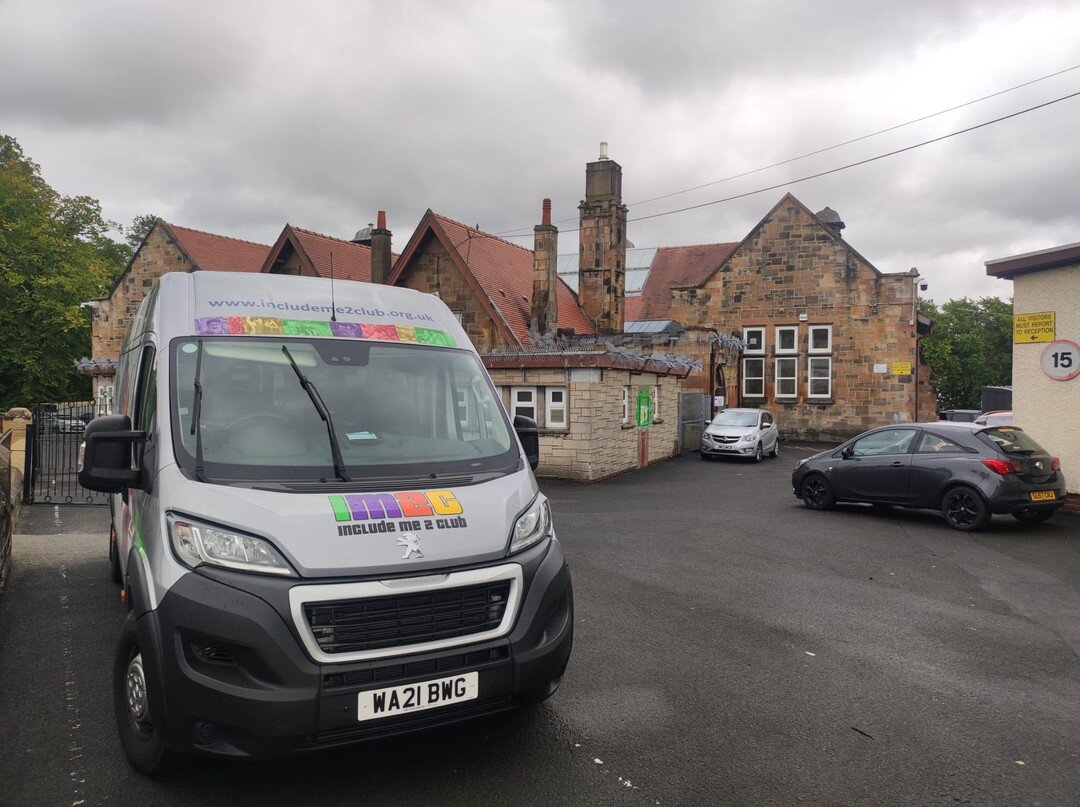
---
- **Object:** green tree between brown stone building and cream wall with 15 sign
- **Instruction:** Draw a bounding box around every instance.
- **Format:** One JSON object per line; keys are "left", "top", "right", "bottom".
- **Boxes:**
{"left": 919, "top": 297, "right": 1012, "bottom": 409}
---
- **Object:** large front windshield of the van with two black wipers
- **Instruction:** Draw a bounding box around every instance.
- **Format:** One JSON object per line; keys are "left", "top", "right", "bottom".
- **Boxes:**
{"left": 172, "top": 337, "right": 518, "bottom": 481}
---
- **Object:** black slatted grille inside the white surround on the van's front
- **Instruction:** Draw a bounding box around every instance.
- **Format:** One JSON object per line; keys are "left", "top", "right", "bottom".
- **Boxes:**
{"left": 303, "top": 580, "right": 510, "bottom": 654}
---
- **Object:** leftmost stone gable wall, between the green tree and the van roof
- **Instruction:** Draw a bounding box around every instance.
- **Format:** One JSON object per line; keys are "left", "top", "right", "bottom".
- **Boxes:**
{"left": 91, "top": 223, "right": 191, "bottom": 359}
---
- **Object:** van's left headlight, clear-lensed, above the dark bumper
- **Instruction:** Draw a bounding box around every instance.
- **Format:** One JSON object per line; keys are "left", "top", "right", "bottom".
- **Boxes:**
{"left": 166, "top": 513, "right": 296, "bottom": 577}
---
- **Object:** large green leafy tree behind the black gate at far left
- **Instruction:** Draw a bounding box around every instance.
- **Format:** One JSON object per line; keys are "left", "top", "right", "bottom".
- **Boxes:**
{"left": 0, "top": 135, "right": 132, "bottom": 412}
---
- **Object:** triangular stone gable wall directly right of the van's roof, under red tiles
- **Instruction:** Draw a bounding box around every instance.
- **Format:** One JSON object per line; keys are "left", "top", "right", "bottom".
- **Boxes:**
{"left": 397, "top": 238, "right": 511, "bottom": 353}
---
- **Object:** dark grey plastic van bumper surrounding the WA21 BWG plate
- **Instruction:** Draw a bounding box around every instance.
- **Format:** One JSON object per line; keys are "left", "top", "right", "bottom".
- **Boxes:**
{"left": 136, "top": 540, "right": 573, "bottom": 757}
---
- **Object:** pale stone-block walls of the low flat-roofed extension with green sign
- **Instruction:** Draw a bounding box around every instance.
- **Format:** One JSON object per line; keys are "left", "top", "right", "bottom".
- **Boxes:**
{"left": 489, "top": 368, "right": 681, "bottom": 482}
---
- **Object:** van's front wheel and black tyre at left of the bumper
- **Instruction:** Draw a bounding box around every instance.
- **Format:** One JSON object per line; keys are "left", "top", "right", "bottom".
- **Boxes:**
{"left": 112, "top": 614, "right": 180, "bottom": 776}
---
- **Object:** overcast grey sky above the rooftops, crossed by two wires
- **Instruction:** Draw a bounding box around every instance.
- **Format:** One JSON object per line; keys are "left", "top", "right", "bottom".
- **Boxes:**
{"left": 0, "top": 0, "right": 1080, "bottom": 301}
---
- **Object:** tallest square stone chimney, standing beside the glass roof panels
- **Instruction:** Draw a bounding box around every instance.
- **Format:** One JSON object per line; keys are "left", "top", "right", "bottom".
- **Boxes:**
{"left": 578, "top": 143, "right": 626, "bottom": 334}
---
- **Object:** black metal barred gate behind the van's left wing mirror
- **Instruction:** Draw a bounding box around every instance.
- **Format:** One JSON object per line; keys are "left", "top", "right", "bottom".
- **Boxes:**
{"left": 24, "top": 400, "right": 111, "bottom": 505}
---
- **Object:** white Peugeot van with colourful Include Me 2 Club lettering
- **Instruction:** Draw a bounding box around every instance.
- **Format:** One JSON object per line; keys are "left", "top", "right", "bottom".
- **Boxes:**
{"left": 79, "top": 271, "right": 573, "bottom": 774}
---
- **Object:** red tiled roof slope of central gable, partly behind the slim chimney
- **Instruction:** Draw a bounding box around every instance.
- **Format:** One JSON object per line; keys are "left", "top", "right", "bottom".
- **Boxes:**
{"left": 434, "top": 213, "right": 595, "bottom": 341}
